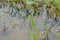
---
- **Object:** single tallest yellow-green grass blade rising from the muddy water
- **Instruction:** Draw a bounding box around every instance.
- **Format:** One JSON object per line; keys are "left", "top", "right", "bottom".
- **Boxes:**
{"left": 29, "top": 15, "right": 37, "bottom": 40}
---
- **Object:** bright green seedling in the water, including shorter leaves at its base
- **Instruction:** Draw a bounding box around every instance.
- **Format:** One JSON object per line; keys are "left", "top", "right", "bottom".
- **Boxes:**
{"left": 29, "top": 15, "right": 40, "bottom": 40}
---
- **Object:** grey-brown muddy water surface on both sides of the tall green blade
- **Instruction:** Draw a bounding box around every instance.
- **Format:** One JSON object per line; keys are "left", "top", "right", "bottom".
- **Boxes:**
{"left": 0, "top": 5, "right": 59, "bottom": 40}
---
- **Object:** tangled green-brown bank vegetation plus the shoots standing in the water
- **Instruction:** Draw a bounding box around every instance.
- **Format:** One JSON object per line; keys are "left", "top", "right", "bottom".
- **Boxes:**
{"left": 0, "top": 0, "right": 60, "bottom": 40}
